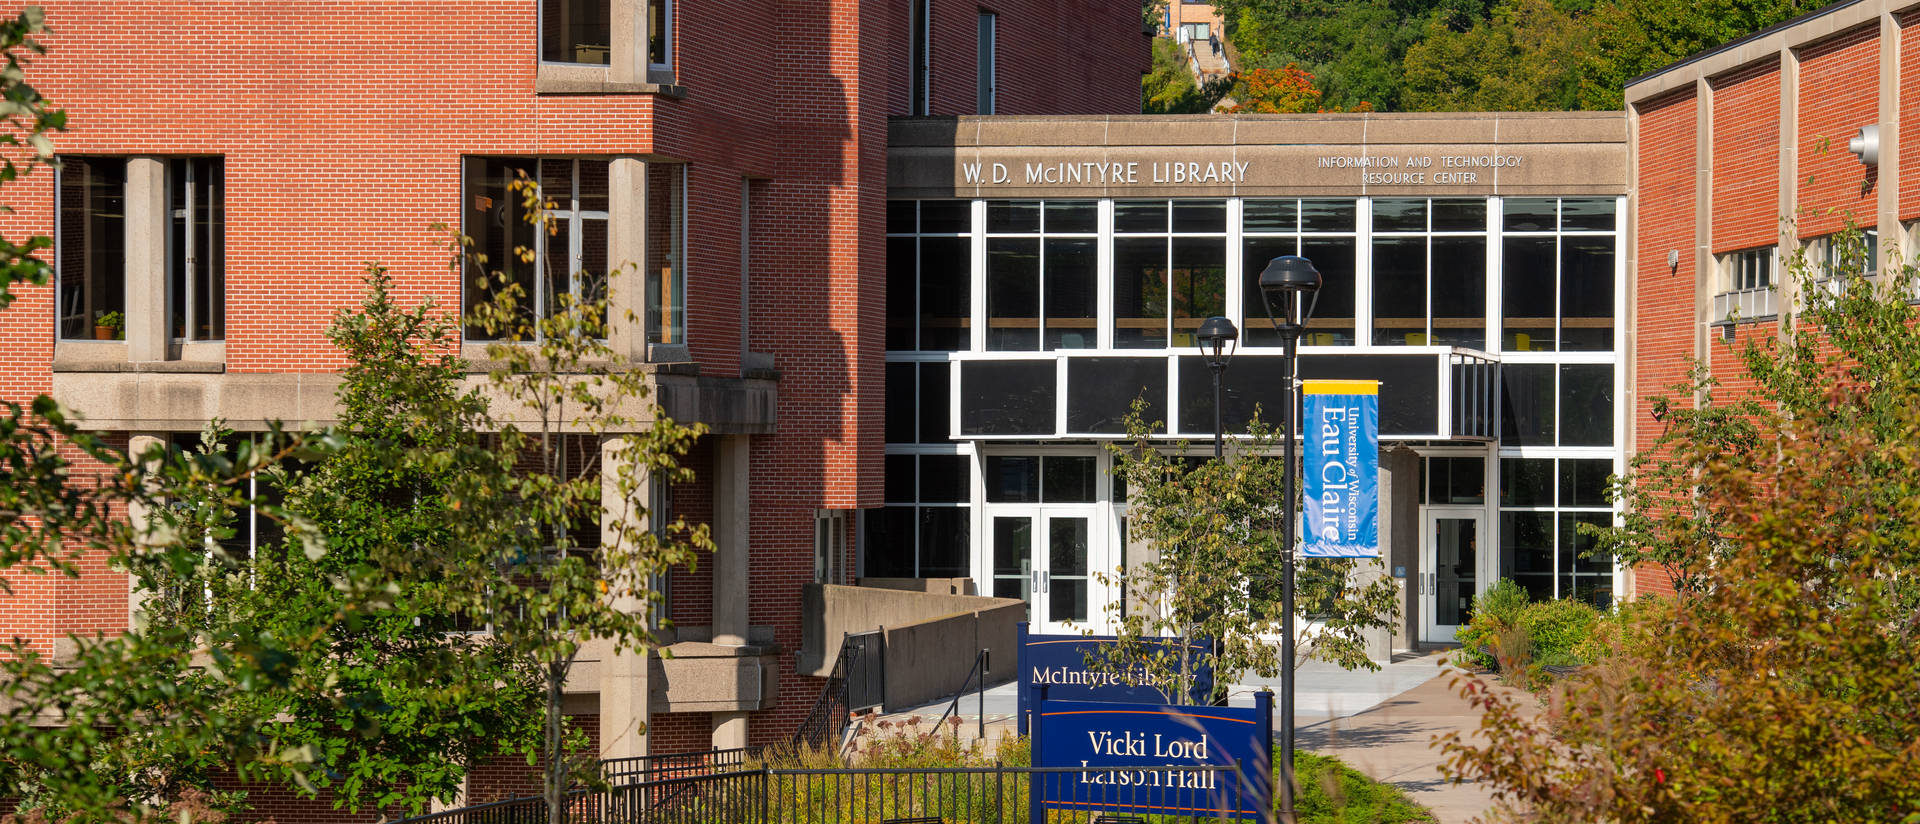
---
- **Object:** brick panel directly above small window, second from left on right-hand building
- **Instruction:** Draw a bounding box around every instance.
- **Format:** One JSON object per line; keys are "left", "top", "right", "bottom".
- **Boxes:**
{"left": 1712, "top": 61, "right": 1780, "bottom": 251}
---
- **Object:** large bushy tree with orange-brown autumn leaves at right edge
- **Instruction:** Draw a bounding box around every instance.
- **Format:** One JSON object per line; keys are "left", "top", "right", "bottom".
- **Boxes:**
{"left": 1446, "top": 224, "right": 1920, "bottom": 822}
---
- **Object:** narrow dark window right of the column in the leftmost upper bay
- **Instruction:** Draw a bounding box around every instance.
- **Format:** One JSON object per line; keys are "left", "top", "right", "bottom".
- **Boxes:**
{"left": 167, "top": 158, "right": 227, "bottom": 342}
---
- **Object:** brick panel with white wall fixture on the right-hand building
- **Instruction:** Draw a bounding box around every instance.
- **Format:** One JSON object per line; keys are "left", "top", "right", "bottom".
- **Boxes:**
{"left": 1797, "top": 25, "right": 1880, "bottom": 238}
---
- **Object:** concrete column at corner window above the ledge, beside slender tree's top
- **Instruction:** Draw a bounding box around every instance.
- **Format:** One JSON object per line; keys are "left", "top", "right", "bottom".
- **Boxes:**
{"left": 607, "top": 155, "right": 647, "bottom": 363}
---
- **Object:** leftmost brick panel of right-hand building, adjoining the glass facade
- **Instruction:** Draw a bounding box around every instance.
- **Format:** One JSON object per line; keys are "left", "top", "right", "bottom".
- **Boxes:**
{"left": 1628, "top": 92, "right": 1703, "bottom": 594}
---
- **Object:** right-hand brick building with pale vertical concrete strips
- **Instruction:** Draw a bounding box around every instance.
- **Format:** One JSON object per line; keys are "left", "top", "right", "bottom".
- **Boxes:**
{"left": 1626, "top": 0, "right": 1920, "bottom": 592}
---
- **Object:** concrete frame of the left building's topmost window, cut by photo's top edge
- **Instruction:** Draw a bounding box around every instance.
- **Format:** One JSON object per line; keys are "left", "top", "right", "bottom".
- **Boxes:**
{"left": 534, "top": 0, "right": 685, "bottom": 98}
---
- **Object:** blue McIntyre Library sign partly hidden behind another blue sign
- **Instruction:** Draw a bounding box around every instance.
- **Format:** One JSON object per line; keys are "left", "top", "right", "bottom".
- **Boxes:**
{"left": 1016, "top": 622, "right": 1213, "bottom": 736}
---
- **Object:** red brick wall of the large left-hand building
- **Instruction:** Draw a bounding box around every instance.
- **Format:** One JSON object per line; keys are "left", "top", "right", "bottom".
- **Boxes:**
{"left": 0, "top": 0, "right": 1148, "bottom": 783}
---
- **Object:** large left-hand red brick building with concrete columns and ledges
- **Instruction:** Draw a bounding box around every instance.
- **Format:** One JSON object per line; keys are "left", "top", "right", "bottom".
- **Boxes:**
{"left": 0, "top": 0, "right": 1148, "bottom": 820}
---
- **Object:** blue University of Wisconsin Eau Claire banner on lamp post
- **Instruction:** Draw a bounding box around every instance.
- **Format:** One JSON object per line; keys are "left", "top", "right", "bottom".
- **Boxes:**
{"left": 1300, "top": 380, "right": 1380, "bottom": 557}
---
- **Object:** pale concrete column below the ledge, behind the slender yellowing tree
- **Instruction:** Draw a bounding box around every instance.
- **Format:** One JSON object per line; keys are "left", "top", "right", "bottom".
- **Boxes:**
{"left": 599, "top": 438, "right": 651, "bottom": 759}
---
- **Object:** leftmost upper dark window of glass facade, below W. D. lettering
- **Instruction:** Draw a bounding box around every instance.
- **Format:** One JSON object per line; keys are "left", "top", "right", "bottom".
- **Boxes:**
{"left": 887, "top": 200, "right": 973, "bottom": 351}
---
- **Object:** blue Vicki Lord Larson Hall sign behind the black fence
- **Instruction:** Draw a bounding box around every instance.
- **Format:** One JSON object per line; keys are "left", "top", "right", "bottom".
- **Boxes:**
{"left": 1029, "top": 691, "right": 1273, "bottom": 822}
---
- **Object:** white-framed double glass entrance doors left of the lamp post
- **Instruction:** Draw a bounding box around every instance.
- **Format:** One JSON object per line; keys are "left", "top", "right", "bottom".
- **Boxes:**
{"left": 987, "top": 507, "right": 1106, "bottom": 634}
